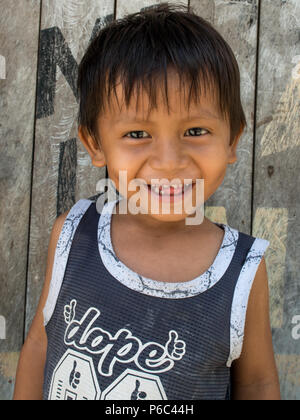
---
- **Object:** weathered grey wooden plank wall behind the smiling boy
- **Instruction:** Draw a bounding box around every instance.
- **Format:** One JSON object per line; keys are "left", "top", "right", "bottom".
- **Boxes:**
{"left": 0, "top": 0, "right": 300, "bottom": 400}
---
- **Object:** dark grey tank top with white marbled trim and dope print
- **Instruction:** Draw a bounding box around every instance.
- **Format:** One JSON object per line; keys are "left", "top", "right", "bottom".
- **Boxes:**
{"left": 43, "top": 195, "right": 269, "bottom": 400}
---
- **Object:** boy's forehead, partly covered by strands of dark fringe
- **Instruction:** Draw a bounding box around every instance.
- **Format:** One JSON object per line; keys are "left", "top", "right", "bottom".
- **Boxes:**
{"left": 99, "top": 71, "right": 223, "bottom": 123}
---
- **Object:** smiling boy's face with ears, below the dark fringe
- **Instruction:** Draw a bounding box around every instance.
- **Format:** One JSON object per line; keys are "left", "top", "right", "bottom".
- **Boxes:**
{"left": 79, "top": 73, "right": 241, "bottom": 230}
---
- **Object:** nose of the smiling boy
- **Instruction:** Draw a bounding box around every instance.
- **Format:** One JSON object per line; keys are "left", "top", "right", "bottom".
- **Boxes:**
{"left": 149, "top": 138, "right": 189, "bottom": 175}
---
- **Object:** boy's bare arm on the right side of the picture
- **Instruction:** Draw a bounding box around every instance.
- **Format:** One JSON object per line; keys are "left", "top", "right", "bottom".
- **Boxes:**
{"left": 232, "top": 257, "right": 280, "bottom": 400}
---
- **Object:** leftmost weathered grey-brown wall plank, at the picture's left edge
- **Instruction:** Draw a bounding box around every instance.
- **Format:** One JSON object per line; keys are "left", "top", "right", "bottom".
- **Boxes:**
{"left": 0, "top": 0, "right": 40, "bottom": 400}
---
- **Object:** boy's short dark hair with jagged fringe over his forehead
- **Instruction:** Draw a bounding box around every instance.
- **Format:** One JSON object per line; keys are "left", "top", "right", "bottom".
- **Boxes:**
{"left": 77, "top": 3, "right": 247, "bottom": 142}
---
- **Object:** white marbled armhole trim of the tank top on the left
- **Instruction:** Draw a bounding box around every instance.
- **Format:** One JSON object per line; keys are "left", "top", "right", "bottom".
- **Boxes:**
{"left": 43, "top": 198, "right": 93, "bottom": 326}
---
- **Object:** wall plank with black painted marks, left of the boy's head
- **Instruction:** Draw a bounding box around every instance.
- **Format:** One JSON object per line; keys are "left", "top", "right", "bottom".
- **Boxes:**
{"left": 26, "top": 0, "right": 114, "bottom": 331}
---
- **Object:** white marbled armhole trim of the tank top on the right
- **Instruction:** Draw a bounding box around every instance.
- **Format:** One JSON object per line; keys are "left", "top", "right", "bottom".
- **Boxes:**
{"left": 226, "top": 238, "right": 270, "bottom": 367}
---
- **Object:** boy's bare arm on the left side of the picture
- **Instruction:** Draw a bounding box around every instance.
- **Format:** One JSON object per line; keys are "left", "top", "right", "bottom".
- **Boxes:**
{"left": 13, "top": 212, "right": 68, "bottom": 400}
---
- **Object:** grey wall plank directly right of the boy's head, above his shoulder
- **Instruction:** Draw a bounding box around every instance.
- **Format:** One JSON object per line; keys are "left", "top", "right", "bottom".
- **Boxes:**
{"left": 190, "top": 0, "right": 258, "bottom": 234}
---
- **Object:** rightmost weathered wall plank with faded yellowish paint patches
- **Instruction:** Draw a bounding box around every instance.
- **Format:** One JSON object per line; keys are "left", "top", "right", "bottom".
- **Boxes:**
{"left": 254, "top": 0, "right": 300, "bottom": 399}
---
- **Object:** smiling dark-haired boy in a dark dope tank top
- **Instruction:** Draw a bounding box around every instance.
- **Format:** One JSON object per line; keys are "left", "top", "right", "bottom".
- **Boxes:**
{"left": 14, "top": 4, "right": 280, "bottom": 400}
